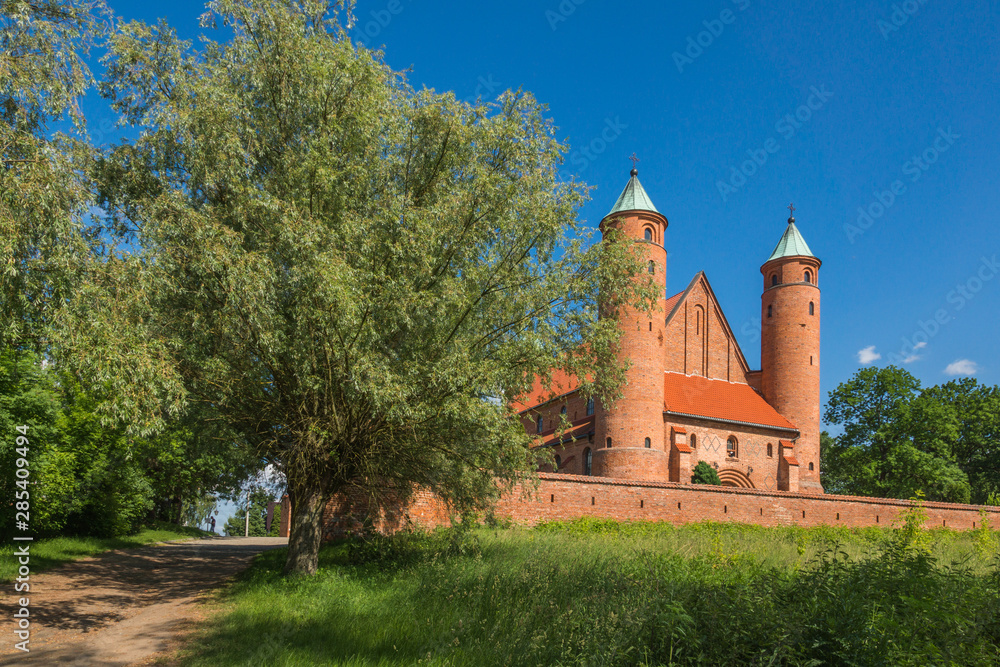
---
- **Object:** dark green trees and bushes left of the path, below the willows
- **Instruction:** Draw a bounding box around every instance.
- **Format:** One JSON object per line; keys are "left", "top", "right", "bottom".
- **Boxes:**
{"left": 0, "top": 348, "right": 258, "bottom": 537}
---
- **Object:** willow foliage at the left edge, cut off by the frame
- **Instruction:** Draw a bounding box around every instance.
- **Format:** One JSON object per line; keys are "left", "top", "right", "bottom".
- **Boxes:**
{"left": 0, "top": 0, "right": 108, "bottom": 349}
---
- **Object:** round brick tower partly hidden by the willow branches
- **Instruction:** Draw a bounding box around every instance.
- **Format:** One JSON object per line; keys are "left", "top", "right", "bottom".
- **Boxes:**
{"left": 592, "top": 168, "right": 669, "bottom": 480}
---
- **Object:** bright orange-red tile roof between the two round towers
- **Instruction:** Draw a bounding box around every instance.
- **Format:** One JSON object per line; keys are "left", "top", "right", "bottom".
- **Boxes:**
{"left": 663, "top": 373, "right": 795, "bottom": 429}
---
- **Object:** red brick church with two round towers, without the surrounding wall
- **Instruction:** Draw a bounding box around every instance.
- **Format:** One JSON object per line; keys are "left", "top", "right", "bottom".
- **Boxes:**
{"left": 516, "top": 169, "right": 823, "bottom": 494}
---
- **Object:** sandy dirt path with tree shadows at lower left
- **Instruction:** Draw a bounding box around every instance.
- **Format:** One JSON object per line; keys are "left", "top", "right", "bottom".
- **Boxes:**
{"left": 0, "top": 537, "right": 287, "bottom": 666}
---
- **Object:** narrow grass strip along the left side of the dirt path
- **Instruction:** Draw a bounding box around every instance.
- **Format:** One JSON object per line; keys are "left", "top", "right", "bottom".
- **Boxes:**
{"left": 0, "top": 522, "right": 211, "bottom": 581}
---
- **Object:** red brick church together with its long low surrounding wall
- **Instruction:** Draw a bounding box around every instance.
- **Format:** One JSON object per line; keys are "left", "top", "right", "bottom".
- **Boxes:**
{"left": 296, "top": 169, "right": 1000, "bottom": 539}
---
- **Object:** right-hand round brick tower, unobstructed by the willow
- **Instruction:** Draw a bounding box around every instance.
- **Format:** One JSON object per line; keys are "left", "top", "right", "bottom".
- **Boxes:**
{"left": 760, "top": 207, "right": 823, "bottom": 493}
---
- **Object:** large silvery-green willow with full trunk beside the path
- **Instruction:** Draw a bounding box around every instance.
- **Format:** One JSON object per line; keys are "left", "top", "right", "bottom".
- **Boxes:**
{"left": 63, "top": 0, "right": 654, "bottom": 573}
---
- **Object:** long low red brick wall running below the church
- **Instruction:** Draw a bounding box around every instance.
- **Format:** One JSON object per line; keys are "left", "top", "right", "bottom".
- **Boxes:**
{"left": 294, "top": 473, "right": 1000, "bottom": 539}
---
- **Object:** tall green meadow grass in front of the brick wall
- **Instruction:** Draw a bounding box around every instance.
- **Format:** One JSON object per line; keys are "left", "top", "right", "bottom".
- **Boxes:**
{"left": 172, "top": 520, "right": 1000, "bottom": 667}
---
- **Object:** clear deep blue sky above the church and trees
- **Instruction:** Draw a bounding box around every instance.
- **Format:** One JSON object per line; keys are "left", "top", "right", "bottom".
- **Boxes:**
{"left": 88, "top": 0, "right": 1000, "bottom": 412}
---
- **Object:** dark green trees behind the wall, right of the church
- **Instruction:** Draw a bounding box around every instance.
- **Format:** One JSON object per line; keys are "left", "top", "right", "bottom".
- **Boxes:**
{"left": 821, "top": 366, "right": 1000, "bottom": 503}
